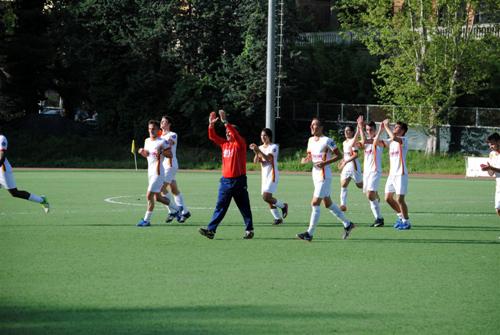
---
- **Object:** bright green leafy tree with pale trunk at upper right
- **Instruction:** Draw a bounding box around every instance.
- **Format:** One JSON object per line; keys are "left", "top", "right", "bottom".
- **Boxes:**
{"left": 338, "top": 0, "right": 499, "bottom": 153}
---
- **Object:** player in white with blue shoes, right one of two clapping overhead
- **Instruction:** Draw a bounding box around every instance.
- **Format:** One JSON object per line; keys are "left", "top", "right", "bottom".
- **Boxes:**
{"left": 382, "top": 119, "right": 411, "bottom": 230}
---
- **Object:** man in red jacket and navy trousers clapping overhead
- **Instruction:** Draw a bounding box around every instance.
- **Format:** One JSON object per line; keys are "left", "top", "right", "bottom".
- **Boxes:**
{"left": 199, "top": 110, "right": 253, "bottom": 239}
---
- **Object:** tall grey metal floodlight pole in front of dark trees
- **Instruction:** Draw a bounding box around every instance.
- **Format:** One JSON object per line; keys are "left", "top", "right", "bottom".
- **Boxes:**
{"left": 266, "top": 0, "right": 276, "bottom": 142}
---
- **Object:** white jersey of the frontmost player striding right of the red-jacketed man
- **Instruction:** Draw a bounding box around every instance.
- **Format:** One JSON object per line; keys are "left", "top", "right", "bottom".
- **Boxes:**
{"left": 307, "top": 136, "right": 337, "bottom": 181}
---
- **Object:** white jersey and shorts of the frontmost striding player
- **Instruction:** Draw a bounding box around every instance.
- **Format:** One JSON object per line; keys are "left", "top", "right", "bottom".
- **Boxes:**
{"left": 307, "top": 136, "right": 337, "bottom": 198}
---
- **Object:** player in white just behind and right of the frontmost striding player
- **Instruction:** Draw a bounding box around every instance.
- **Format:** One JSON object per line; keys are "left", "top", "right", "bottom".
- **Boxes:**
{"left": 338, "top": 126, "right": 363, "bottom": 212}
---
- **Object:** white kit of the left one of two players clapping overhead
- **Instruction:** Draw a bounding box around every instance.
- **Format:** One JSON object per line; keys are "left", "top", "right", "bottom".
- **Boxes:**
{"left": 363, "top": 141, "right": 385, "bottom": 193}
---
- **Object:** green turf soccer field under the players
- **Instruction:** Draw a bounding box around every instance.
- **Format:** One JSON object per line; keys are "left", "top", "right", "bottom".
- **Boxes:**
{"left": 0, "top": 170, "right": 500, "bottom": 335}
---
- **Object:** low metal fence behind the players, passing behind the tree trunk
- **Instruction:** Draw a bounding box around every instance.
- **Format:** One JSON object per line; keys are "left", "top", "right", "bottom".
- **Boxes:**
{"left": 279, "top": 101, "right": 500, "bottom": 127}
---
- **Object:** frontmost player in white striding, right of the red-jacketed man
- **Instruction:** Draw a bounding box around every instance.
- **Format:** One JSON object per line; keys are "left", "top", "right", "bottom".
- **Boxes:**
{"left": 297, "top": 118, "right": 355, "bottom": 242}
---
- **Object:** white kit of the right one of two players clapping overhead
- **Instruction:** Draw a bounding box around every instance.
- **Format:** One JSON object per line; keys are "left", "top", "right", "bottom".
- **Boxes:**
{"left": 385, "top": 137, "right": 408, "bottom": 195}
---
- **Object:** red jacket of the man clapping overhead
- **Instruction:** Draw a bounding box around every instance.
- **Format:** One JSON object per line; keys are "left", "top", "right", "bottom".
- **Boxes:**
{"left": 208, "top": 123, "right": 247, "bottom": 178}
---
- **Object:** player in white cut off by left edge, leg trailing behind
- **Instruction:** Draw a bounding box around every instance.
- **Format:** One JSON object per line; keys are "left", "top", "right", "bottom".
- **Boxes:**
{"left": 0, "top": 129, "right": 50, "bottom": 213}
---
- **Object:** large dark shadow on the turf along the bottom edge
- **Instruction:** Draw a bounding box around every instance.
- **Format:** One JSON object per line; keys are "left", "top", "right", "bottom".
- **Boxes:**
{"left": 0, "top": 306, "right": 378, "bottom": 335}
